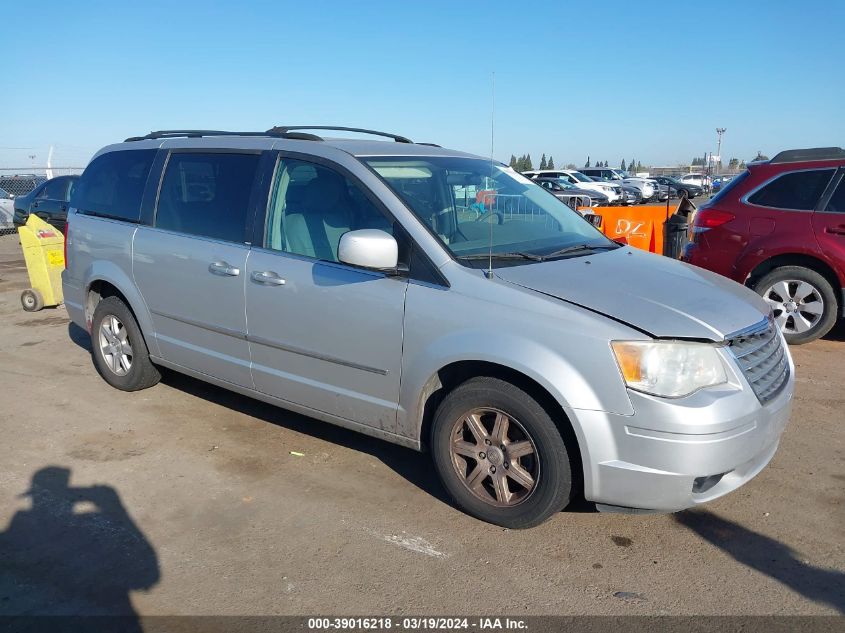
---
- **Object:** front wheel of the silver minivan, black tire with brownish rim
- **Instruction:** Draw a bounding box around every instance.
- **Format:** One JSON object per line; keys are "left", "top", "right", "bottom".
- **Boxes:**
{"left": 431, "top": 378, "right": 572, "bottom": 528}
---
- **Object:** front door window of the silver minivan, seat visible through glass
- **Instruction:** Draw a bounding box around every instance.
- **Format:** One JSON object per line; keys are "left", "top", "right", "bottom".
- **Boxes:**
{"left": 264, "top": 158, "right": 392, "bottom": 262}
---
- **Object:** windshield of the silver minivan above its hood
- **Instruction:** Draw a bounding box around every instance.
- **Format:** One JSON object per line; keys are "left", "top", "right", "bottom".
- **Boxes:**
{"left": 361, "top": 156, "right": 618, "bottom": 266}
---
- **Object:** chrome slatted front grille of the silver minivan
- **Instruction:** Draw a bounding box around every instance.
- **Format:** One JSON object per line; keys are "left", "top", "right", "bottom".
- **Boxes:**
{"left": 728, "top": 319, "right": 789, "bottom": 404}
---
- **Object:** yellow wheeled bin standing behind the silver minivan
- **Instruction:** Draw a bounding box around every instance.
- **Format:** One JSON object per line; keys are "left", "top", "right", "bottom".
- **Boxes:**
{"left": 18, "top": 213, "right": 65, "bottom": 312}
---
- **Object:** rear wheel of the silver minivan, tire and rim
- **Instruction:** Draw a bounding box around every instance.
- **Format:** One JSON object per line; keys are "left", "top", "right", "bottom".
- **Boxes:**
{"left": 91, "top": 297, "right": 161, "bottom": 391}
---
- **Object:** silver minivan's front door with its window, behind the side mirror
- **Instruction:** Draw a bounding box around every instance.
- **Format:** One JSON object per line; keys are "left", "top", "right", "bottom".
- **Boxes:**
{"left": 246, "top": 158, "right": 407, "bottom": 429}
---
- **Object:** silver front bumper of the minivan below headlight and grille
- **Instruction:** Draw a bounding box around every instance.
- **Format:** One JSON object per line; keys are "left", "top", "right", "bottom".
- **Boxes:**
{"left": 572, "top": 348, "right": 795, "bottom": 512}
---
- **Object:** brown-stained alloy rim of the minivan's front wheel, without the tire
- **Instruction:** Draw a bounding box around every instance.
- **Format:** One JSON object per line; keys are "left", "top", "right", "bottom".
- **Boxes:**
{"left": 450, "top": 408, "right": 540, "bottom": 507}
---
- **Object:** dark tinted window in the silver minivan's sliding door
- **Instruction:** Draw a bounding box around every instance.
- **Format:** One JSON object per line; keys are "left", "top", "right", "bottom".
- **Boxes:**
{"left": 155, "top": 152, "right": 259, "bottom": 243}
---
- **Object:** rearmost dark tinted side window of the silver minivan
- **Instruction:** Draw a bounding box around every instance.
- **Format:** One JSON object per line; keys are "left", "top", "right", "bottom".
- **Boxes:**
{"left": 70, "top": 149, "right": 156, "bottom": 222}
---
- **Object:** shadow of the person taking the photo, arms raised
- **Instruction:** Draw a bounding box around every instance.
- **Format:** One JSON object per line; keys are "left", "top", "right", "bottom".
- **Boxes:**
{"left": 0, "top": 466, "right": 160, "bottom": 631}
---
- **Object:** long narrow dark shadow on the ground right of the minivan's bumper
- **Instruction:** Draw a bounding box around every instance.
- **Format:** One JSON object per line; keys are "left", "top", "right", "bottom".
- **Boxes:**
{"left": 674, "top": 510, "right": 845, "bottom": 614}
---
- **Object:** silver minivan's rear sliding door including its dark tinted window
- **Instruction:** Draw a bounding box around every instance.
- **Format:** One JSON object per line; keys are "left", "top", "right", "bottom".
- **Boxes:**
{"left": 132, "top": 152, "right": 260, "bottom": 387}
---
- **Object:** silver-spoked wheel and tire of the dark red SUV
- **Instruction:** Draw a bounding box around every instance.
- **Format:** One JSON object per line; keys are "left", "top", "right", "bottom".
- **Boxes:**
{"left": 754, "top": 266, "right": 839, "bottom": 345}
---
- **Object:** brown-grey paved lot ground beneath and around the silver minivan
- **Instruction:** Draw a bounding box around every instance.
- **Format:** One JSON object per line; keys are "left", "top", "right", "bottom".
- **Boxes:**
{"left": 0, "top": 231, "right": 845, "bottom": 615}
